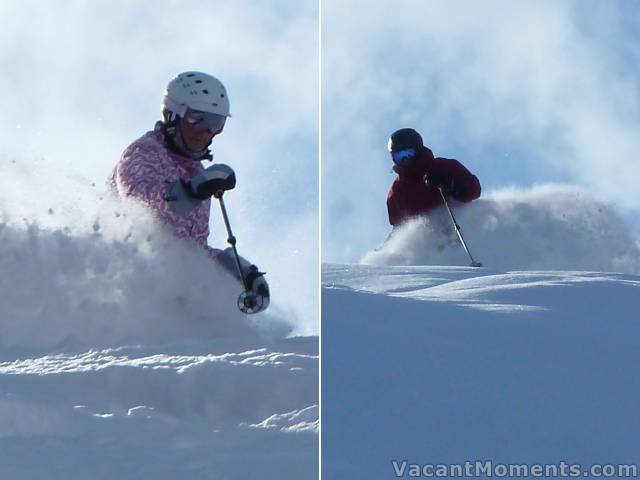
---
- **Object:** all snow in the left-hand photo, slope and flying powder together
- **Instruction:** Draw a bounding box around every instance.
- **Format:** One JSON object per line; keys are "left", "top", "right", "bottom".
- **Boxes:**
{"left": 0, "top": 164, "right": 318, "bottom": 479}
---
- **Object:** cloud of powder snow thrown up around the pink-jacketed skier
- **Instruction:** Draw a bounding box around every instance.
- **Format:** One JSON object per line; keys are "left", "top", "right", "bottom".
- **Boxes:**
{"left": 0, "top": 162, "right": 290, "bottom": 352}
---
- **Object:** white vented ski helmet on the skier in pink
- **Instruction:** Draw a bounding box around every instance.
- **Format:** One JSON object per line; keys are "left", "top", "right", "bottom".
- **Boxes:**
{"left": 162, "top": 72, "right": 231, "bottom": 117}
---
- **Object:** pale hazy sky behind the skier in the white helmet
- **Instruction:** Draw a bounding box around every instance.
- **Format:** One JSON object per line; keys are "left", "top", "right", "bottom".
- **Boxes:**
{"left": 0, "top": 0, "right": 319, "bottom": 333}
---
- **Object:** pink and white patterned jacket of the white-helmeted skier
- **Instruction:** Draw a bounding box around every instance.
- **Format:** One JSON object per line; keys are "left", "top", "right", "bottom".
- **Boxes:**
{"left": 110, "top": 122, "right": 219, "bottom": 251}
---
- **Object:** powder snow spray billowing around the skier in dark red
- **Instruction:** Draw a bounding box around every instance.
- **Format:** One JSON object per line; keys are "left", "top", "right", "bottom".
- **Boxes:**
{"left": 361, "top": 185, "right": 640, "bottom": 273}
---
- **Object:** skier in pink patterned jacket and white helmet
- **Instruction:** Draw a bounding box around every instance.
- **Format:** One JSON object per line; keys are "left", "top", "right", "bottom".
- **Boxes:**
{"left": 110, "top": 72, "right": 269, "bottom": 310}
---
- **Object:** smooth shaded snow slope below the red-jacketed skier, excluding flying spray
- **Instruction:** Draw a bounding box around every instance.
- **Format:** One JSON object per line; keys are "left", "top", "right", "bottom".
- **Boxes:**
{"left": 321, "top": 264, "right": 640, "bottom": 479}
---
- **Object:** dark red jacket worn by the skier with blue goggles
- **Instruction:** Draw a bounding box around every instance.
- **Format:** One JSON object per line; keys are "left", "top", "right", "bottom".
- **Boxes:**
{"left": 387, "top": 147, "right": 481, "bottom": 226}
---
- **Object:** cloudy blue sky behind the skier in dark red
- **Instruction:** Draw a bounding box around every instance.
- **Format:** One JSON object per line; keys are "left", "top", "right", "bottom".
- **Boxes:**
{"left": 322, "top": 0, "right": 640, "bottom": 262}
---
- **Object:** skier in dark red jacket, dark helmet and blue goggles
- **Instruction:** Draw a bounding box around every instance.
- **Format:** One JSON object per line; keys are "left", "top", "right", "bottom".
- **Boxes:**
{"left": 387, "top": 128, "right": 480, "bottom": 227}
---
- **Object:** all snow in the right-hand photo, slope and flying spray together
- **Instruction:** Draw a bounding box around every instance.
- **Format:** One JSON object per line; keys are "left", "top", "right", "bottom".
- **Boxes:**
{"left": 321, "top": 189, "right": 640, "bottom": 479}
